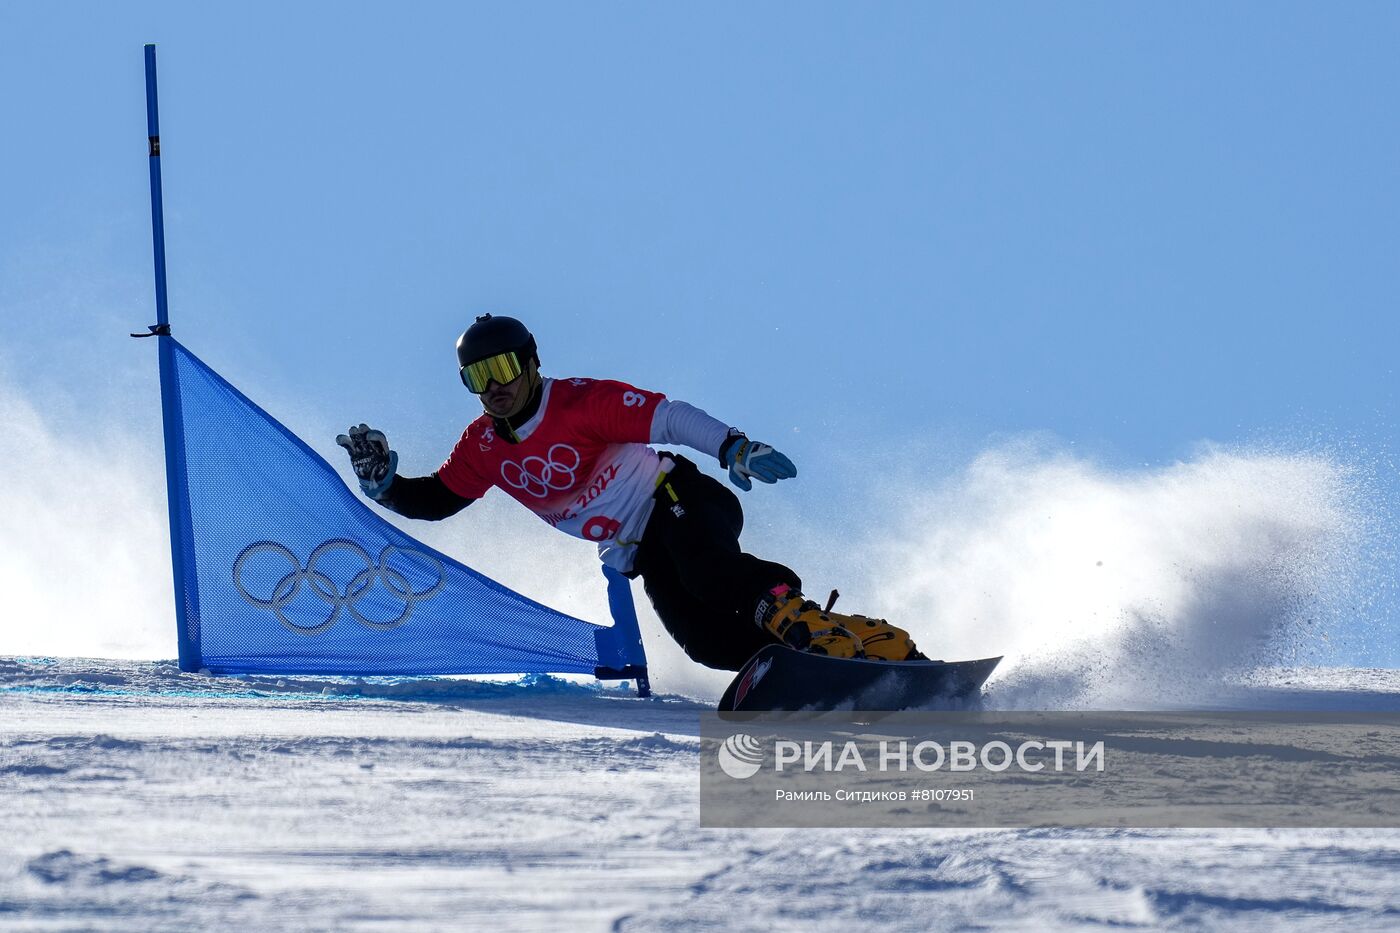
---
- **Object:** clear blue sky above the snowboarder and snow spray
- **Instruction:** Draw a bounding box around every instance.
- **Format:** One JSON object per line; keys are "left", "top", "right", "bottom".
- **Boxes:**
{"left": 0, "top": 3, "right": 1400, "bottom": 664}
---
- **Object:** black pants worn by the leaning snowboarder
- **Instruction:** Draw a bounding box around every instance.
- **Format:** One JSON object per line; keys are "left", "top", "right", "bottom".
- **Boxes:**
{"left": 630, "top": 454, "right": 802, "bottom": 671}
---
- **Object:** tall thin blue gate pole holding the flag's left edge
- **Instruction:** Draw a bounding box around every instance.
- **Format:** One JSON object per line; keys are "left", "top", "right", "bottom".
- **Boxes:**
{"left": 146, "top": 45, "right": 203, "bottom": 671}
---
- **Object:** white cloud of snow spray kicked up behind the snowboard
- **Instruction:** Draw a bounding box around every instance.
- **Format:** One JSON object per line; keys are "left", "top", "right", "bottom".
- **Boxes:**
{"left": 845, "top": 441, "right": 1373, "bottom": 707}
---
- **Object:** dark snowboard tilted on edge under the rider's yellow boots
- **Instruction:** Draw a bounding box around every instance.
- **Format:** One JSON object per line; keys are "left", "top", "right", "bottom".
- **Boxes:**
{"left": 720, "top": 644, "right": 1001, "bottom": 713}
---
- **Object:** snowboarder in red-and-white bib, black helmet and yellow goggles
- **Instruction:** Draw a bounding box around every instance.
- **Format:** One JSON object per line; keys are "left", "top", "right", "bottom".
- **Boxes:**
{"left": 336, "top": 314, "right": 924, "bottom": 671}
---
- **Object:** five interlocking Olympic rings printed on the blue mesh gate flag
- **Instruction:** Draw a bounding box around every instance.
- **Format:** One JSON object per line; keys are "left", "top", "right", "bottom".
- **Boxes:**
{"left": 234, "top": 538, "right": 447, "bottom": 635}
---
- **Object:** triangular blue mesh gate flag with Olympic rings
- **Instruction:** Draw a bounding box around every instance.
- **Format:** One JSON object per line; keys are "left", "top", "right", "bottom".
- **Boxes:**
{"left": 157, "top": 335, "right": 645, "bottom": 677}
